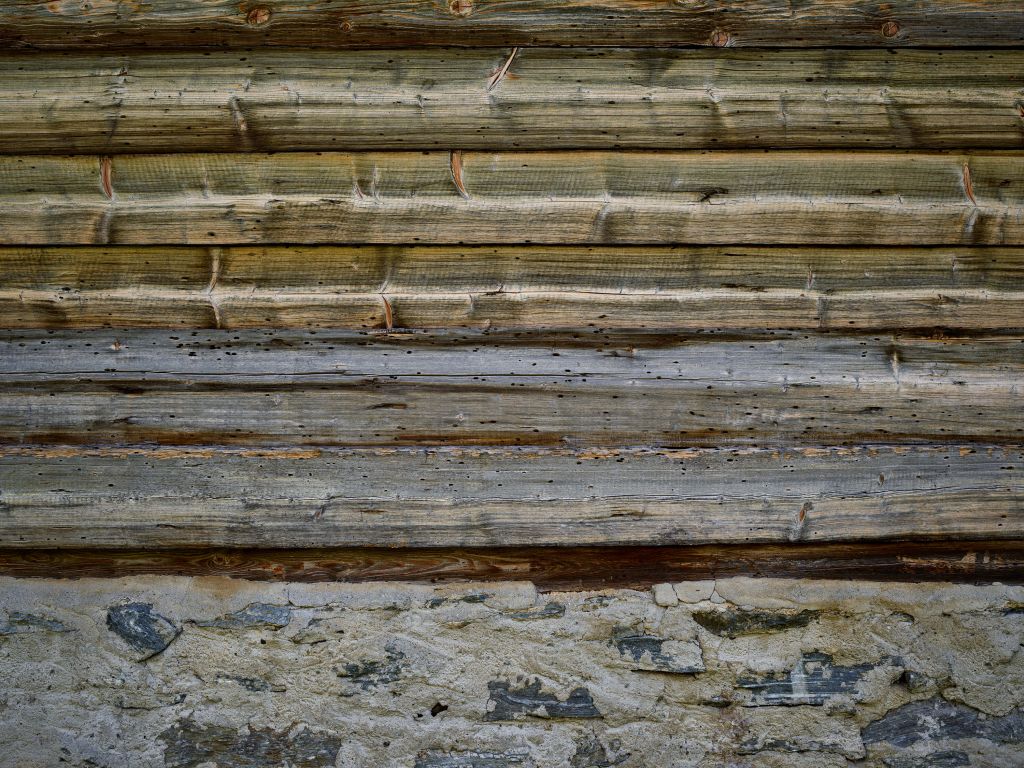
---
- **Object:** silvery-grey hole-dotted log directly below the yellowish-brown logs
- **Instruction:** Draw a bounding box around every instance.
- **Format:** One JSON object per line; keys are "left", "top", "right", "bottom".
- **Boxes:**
{"left": 0, "top": 331, "right": 1024, "bottom": 446}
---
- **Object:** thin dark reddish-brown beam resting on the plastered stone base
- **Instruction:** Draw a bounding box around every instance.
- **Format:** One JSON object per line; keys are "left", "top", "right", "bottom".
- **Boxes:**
{"left": 0, "top": 541, "right": 1024, "bottom": 591}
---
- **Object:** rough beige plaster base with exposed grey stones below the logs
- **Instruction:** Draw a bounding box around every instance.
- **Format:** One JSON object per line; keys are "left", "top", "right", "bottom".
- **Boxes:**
{"left": 0, "top": 578, "right": 1024, "bottom": 768}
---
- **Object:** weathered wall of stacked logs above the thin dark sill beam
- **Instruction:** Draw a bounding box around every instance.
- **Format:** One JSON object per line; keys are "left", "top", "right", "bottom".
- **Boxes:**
{"left": 0, "top": 0, "right": 1024, "bottom": 584}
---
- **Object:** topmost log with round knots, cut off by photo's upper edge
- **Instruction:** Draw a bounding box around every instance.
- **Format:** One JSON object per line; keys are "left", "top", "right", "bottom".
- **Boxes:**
{"left": 0, "top": 0, "right": 1024, "bottom": 48}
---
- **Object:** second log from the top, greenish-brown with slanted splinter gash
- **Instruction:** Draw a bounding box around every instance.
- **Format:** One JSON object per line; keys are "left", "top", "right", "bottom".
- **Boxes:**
{"left": 0, "top": 49, "right": 1024, "bottom": 154}
